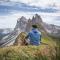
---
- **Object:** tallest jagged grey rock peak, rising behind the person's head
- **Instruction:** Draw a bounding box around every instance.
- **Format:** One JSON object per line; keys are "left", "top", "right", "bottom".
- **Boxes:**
{"left": 26, "top": 14, "right": 43, "bottom": 32}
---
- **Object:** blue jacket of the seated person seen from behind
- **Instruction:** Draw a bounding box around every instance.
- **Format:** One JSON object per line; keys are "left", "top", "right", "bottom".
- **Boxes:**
{"left": 28, "top": 29, "right": 41, "bottom": 45}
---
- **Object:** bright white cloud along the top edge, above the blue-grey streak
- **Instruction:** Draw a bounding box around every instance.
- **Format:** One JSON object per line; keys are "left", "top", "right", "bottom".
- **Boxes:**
{"left": 11, "top": 0, "right": 60, "bottom": 6}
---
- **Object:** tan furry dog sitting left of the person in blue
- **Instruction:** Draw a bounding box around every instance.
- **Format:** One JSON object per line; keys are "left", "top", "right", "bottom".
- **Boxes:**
{"left": 14, "top": 32, "right": 28, "bottom": 45}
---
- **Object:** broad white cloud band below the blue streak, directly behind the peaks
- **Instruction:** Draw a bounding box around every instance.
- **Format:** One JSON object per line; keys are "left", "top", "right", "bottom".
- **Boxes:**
{"left": 0, "top": 12, "right": 60, "bottom": 28}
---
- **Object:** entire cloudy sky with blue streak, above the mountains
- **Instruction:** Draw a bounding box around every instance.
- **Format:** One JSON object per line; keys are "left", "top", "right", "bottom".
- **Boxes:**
{"left": 0, "top": 0, "right": 60, "bottom": 28}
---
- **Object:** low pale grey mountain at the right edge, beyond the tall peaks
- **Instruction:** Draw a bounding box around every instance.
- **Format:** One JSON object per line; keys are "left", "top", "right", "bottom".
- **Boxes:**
{"left": 44, "top": 23, "right": 60, "bottom": 38}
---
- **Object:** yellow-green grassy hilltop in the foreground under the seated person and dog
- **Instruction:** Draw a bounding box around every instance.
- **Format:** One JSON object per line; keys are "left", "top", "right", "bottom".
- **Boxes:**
{"left": 0, "top": 38, "right": 56, "bottom": 60}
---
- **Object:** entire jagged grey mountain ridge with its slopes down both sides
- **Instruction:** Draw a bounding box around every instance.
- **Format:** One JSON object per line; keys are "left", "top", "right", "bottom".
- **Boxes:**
{"left": 1, "top": 14, "right": 60, "bottom": 46}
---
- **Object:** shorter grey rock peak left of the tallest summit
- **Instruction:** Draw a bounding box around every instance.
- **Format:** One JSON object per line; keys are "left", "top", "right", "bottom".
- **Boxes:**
{"left": 15, "top": 16, "right": 27, "bottom": 32}
